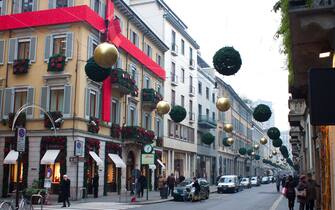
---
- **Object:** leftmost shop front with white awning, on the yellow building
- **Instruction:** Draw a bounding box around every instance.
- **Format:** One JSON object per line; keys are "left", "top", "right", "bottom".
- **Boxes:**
{"left": 2, "top": 137, "right": 29, "bottom": 197}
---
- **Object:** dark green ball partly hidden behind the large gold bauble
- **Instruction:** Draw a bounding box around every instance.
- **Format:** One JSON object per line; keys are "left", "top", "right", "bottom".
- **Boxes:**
{"left": 85, "top": 57, "right": 111, "bottom": 82}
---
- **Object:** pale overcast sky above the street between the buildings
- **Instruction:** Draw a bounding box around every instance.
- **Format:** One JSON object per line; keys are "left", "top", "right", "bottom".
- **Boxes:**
{"left": 165, "top": 0, "right": 289, "bottom": 130}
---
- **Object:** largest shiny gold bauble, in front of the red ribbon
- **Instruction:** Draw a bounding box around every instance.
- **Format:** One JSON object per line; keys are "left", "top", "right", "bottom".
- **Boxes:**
{"left": 93, "top": 42, "right": 119, "bottom": 68}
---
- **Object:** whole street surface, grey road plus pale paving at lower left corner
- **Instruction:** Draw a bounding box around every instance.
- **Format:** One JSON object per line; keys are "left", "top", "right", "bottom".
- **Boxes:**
{"left": 38, "top": 184, "right": 298, "bottom": 210}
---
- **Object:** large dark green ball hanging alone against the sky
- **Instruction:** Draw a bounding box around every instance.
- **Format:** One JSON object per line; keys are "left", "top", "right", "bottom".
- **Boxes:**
{"left": 213, "top": 47, "right": 242, "bottom": 76}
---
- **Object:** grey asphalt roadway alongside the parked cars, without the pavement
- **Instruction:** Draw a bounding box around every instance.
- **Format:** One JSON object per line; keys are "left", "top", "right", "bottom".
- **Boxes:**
{"left": 132, "top": 184, "right": 286, "bottom": 210}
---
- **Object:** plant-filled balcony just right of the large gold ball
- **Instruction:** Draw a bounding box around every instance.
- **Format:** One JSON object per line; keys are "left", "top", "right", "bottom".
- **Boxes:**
{"left": 111, "top": 68, "right": 138, "bottom": 95}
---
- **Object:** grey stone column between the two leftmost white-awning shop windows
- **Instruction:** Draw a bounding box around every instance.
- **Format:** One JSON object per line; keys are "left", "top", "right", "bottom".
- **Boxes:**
{"left": 27, "top": 137, "right": 41, "bottom": 186}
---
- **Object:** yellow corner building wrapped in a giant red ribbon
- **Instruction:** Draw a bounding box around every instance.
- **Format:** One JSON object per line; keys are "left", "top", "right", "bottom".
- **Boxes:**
{"left": 0, "top": 0, "right": 168, "bottom": 199}
